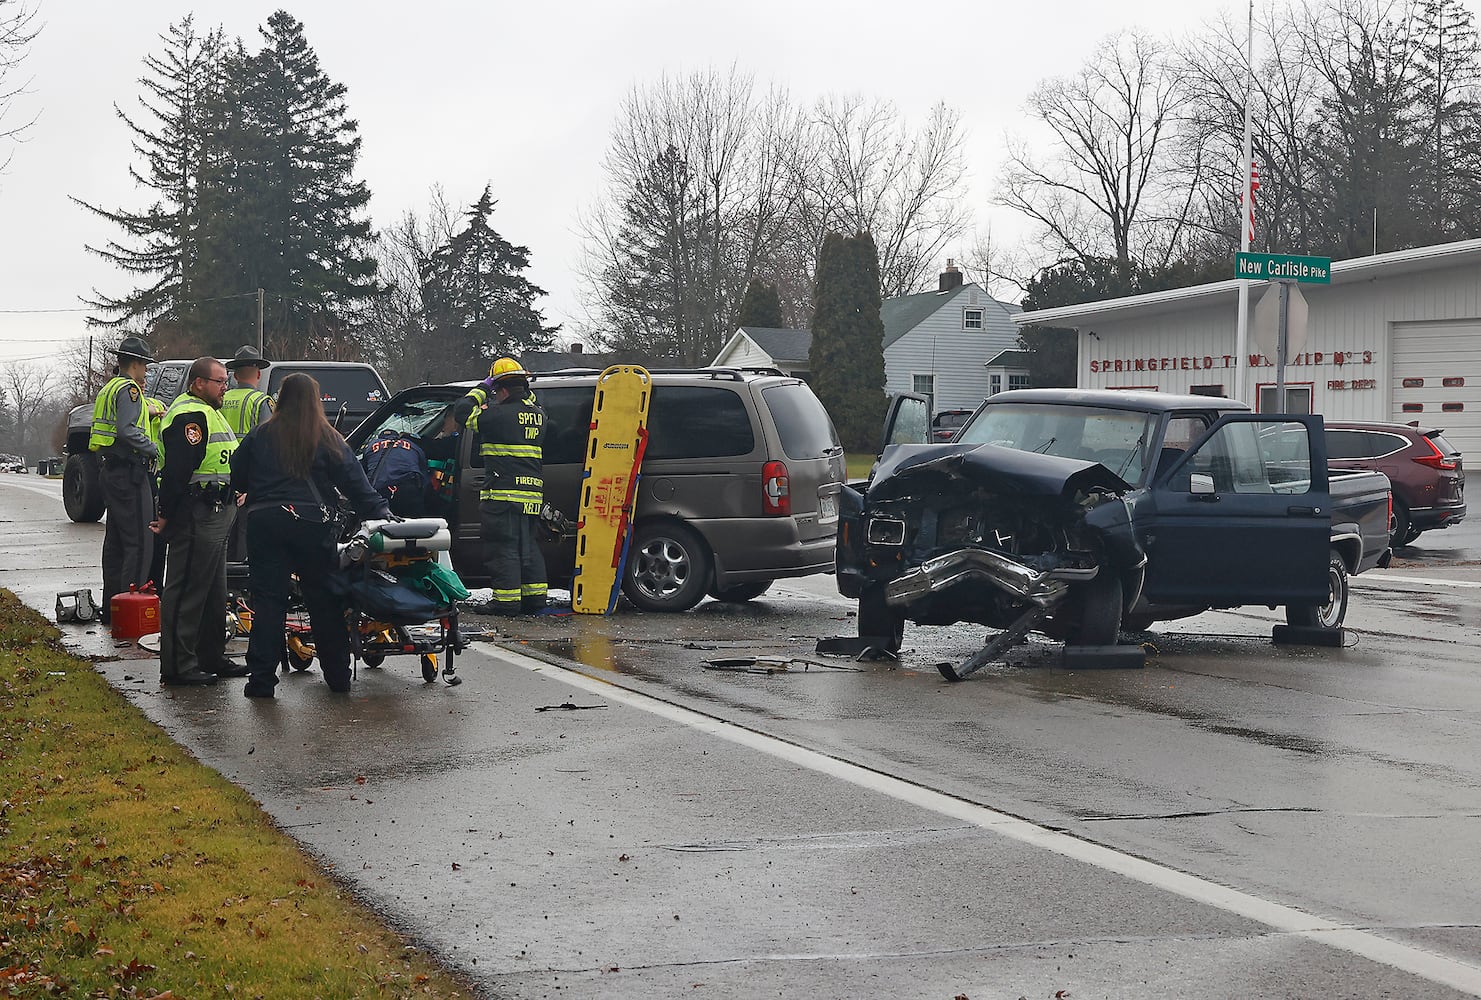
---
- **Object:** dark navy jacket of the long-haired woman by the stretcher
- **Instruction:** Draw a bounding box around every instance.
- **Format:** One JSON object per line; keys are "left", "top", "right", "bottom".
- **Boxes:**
{"left": 228, "top": 421, "right": 391, "bottom": 519}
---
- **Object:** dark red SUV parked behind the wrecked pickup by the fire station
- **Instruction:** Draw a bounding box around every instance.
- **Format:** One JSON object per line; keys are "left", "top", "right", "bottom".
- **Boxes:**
{"left": 1327, "top": 422, "right": 1466, "bottom": 548}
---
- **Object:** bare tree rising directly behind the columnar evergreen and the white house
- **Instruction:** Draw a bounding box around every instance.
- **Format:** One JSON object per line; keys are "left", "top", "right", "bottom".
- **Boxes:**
{"left": 798, "top": 95, "right": 970, "bottom": 298}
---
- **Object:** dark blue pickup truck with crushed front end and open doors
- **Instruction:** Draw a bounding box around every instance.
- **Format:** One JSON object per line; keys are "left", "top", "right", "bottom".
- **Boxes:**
{"left": 837, "top": 390, "right": 1392, "bottom": 650}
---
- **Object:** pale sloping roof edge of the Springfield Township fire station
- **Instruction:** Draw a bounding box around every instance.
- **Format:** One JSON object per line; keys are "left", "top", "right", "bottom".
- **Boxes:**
{"left": 1013, "top": 240, "right": 1481, "bottom": 329}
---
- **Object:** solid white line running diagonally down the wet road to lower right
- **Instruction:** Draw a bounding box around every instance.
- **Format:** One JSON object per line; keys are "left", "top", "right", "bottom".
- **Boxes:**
{"left": 490, "top": 647, "right": 1481, "bottom": 996}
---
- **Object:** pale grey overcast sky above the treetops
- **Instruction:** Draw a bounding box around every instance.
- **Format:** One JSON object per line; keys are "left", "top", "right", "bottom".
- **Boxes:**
{"left": 0, "top": 0, "right": 1309, "bottom": 363}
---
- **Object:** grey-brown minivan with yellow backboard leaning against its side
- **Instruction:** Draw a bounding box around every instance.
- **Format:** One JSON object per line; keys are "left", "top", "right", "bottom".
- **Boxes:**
{"left": 348, "top": 369, "right": 844, "bottom": 612}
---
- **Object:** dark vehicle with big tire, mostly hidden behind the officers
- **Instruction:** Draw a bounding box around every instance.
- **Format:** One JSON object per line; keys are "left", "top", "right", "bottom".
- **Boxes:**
{"left": 62, "top": 359, "right": 391, "bottom": 523}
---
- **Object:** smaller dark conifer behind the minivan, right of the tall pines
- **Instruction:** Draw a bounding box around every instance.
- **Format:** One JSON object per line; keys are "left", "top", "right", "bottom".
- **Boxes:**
{"left": 422, "top": 187, "right": 557, "bottom": 378}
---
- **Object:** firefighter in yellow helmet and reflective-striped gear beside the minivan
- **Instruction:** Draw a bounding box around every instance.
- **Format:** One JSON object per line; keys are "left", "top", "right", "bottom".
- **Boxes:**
{"left": 452, "top": 357, "right": 546, "bottom": 615}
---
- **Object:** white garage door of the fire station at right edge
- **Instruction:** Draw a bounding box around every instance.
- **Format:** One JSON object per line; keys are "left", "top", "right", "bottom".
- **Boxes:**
{"left": 1389, "top": 320, "right": 1481, "bottom": 471}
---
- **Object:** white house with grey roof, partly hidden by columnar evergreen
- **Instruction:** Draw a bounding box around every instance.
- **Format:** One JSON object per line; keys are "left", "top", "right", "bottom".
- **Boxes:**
{"left": 712, "top": 261, "right": 1028, "bottom": 412}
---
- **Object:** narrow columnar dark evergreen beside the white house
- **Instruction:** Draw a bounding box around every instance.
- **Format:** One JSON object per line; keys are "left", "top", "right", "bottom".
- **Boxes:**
{"left": 807, "top": 233, "right": 886, "bottom": 453}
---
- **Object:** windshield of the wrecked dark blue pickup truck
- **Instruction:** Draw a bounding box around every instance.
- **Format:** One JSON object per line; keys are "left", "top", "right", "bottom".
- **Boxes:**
{"left": 957, "top": 403, "right": 1157, "bottom": 484}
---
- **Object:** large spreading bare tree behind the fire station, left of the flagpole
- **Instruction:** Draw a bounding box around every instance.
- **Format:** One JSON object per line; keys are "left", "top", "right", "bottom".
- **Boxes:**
{"left": 1000, "top": 31, "right": 1206, "bottom": 280}
